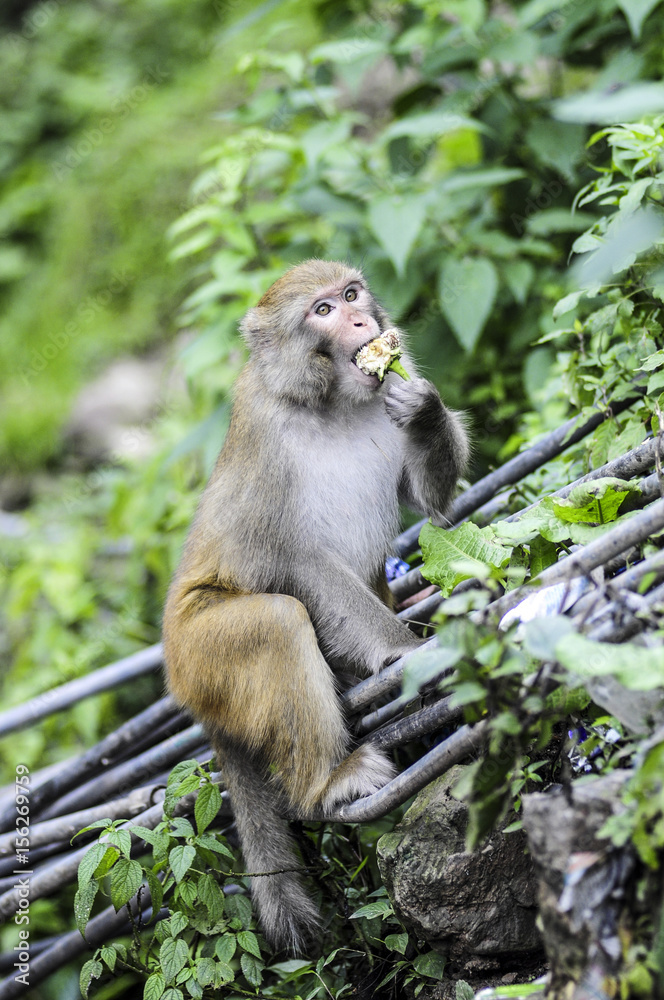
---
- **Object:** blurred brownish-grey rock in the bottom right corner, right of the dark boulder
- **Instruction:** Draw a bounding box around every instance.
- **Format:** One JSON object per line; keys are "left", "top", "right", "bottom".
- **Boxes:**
{"left": 523, "top": 771, "right": 634, "bottom": 998}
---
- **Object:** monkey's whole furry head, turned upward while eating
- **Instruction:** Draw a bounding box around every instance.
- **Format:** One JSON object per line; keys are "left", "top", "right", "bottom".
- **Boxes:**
{"left": 241, "top": 260, "right": 389, "bottom": 406}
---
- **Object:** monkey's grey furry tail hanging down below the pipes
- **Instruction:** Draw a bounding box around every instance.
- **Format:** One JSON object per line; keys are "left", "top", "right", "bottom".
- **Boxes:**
{"left": 214, "top": 733, "right": 320, "bottom": 955}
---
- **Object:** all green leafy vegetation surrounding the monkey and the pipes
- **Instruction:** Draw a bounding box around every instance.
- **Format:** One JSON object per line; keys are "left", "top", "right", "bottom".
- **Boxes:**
{"left": 0, "top": 0, "right": 664, "bottom": 1000}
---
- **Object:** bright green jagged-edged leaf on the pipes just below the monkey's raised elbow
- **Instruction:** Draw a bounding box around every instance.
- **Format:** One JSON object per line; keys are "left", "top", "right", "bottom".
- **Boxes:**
{"left": 420, "top": 521, "right": 512, "bottom": 595}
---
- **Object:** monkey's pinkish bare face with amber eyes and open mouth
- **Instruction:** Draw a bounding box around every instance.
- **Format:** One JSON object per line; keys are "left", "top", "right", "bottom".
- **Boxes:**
{"left": 304, "top": 280, "right": 381, "bottom": 394}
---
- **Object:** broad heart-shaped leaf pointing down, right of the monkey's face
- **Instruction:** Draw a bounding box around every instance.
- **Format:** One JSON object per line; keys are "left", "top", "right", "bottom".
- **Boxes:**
{"left": 438, "top": 257, "right": 498, "bottom": 352}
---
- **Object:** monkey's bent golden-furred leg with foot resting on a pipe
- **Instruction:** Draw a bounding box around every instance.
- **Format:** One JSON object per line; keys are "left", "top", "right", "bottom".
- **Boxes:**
{"left": 164, "top": 588, "right": 394, "bottom": 818}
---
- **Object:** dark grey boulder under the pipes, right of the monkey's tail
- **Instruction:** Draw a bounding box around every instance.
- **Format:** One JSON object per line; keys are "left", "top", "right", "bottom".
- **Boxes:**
{"left": 378, "top": 765, "right": 541, "bottom": 969}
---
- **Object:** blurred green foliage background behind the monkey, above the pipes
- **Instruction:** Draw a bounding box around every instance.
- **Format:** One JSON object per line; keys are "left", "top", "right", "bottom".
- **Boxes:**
{"left": 0, "top": 0, "right": 664, "bottom": 995}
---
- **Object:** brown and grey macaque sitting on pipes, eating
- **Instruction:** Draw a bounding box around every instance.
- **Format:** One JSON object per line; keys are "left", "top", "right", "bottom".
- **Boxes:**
{"left": 164, "top": 260, "right": 468, "bottom": 953}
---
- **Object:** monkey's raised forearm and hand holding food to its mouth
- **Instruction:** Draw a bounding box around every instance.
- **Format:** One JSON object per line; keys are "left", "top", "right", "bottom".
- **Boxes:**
{"left": 385, "top": 378, "right": 469, "bottom": 522}
